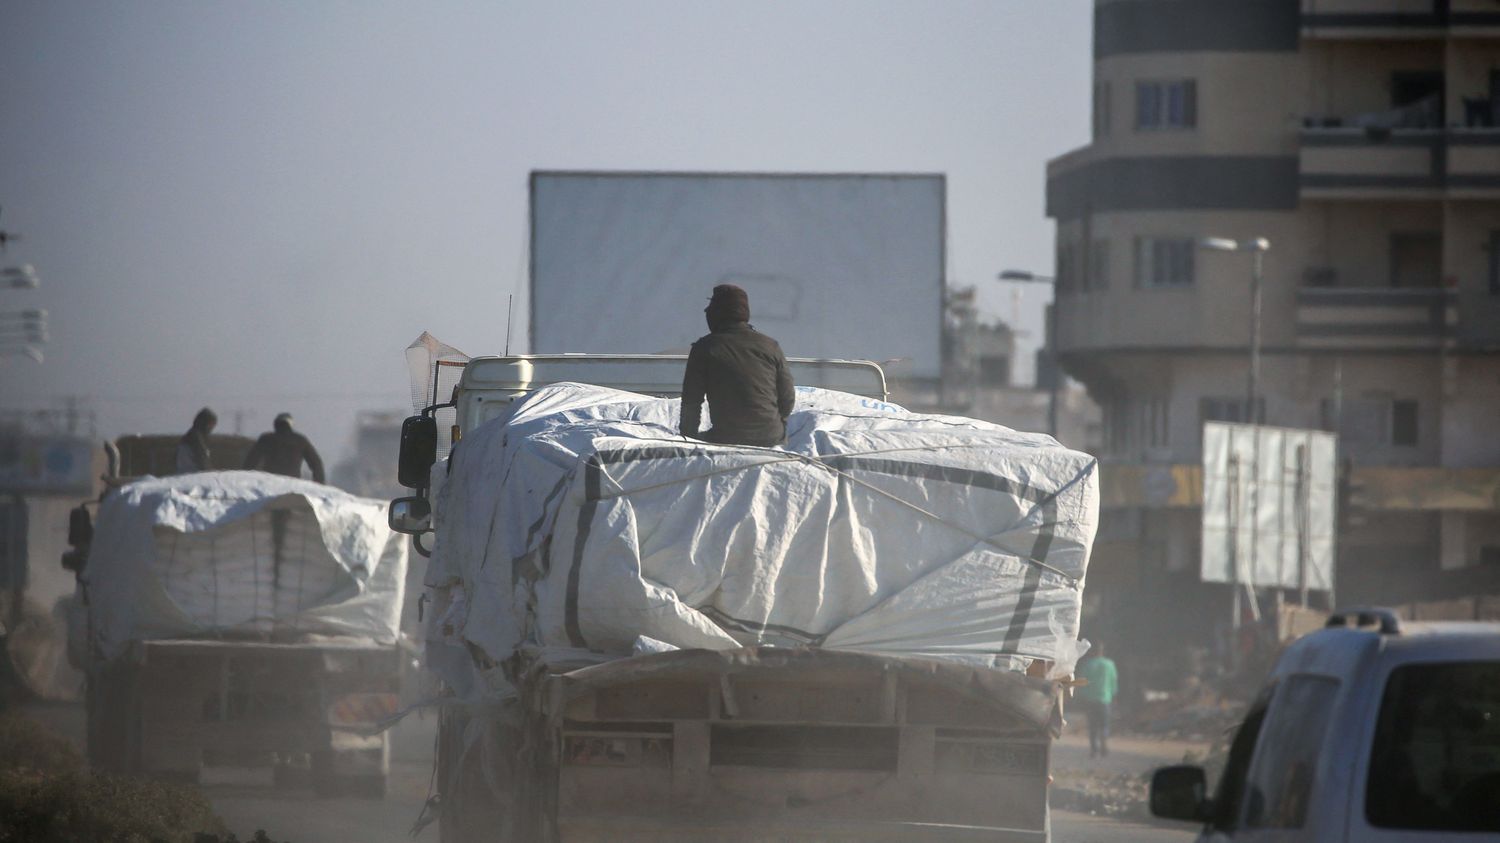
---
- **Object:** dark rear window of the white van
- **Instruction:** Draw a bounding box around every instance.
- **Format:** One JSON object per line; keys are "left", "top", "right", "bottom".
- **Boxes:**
{"left": 1365, "top": 662, "right": 1500, "bottom": 831}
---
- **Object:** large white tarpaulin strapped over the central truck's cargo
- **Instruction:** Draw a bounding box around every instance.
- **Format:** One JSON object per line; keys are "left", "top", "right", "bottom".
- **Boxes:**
{"left": 428, "top": 384, "right": 1098, "bottom": 695}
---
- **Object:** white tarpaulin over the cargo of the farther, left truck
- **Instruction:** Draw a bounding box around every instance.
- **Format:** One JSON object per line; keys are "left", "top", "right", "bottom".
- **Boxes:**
{"left": 84, "top": 471, "right": 407, "bottom": 659}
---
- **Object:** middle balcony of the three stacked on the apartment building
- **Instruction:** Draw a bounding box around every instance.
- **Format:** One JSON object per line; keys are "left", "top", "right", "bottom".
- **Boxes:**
{"left": 1298, "top": 126, "right": 1500, "bottom": 200}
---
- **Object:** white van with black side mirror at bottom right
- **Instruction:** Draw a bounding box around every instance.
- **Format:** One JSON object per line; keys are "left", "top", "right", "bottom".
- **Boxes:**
{"left": 1151, "top": 608, "right": 1500, "bottom": 843}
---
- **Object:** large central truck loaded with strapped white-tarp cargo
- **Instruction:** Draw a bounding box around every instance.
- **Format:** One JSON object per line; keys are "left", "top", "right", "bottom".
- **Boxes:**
{"left": 389, "top": 356, "right": 1098, "bottom": 843}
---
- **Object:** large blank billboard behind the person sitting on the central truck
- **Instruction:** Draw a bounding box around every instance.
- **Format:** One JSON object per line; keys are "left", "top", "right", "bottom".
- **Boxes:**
{"left": 531, "top": 173, "right": 945, "bottom": 378}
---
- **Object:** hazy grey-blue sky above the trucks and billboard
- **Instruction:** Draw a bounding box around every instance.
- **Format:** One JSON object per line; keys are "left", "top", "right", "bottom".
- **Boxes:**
{"left": 0, "top": 0, "right": 1092, "bottom": 459}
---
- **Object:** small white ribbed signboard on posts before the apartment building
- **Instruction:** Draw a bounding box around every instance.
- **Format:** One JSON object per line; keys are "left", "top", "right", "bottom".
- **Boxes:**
{"left": 1203, "top": 422, "right": 1338, "bottom": 591}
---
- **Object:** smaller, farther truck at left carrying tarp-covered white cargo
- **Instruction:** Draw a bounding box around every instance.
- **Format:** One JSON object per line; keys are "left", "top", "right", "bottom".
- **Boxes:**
{"left": 63, "top": 437, "right": 407, "bottom": 797}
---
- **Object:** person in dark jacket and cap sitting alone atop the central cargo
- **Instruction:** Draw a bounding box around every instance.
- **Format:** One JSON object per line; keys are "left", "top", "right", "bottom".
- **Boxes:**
{"left": 681, "top": 284, "right": 797, "bottom": 447}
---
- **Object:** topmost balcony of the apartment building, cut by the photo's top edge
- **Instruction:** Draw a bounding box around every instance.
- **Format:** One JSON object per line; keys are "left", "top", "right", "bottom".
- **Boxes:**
{"left": 1302, "top": 0, "right": 1500, "bottom": 39}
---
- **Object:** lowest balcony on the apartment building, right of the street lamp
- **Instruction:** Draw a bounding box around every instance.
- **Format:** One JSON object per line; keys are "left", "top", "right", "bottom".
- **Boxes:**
{"left": 1296, "top": 287, "right": 1458, "bottom": 350}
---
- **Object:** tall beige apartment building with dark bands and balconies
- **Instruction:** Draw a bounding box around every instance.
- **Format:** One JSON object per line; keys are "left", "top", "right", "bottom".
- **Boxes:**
{"left": 1047, "top": 0, "right": 1500, "bottom": 684}
